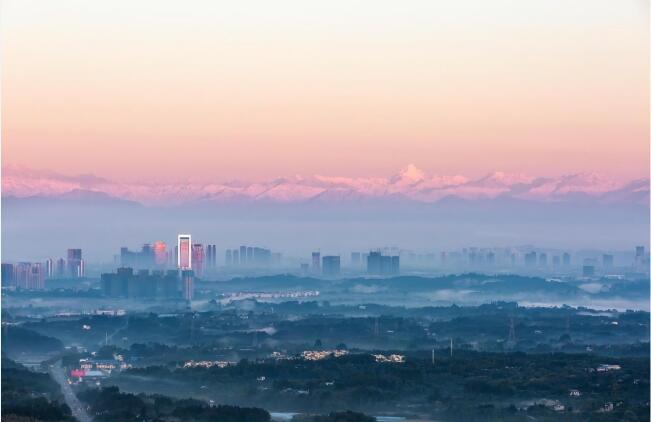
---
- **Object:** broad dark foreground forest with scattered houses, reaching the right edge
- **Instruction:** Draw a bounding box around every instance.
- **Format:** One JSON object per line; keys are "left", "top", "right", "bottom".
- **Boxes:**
{"left": 108, "top": 350, "right": 649, "bottom": 420}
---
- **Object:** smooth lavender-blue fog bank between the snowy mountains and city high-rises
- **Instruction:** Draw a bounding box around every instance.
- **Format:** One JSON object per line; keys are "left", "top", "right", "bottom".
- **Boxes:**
{"left": 2, "top": 192, "right": 649, "bottom": 262}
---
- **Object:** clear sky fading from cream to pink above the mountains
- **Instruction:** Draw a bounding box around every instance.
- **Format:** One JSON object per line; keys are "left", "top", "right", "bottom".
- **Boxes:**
{"left": 0, "top": 0, "right": 649, "bottom": 181}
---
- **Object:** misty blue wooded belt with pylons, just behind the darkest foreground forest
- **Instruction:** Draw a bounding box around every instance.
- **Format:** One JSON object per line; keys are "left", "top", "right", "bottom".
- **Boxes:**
{"left": 11, "top": 301, "right": 649, "bottom": 356}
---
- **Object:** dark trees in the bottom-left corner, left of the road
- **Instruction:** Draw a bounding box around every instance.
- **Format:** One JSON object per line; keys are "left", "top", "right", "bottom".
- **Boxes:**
{"left": 2, "top": 356, "right": 75, "bottom": 421}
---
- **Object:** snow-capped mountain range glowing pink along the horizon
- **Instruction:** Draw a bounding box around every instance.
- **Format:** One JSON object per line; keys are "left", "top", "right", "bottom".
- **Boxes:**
{"left": 2, "top": 164, "right": 649, "bottom": 205}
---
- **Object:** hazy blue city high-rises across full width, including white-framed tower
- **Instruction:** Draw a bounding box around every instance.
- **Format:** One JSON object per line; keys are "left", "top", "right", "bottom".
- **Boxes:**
{"left": 2, "top": 234, "right": 650, "bottom": 290}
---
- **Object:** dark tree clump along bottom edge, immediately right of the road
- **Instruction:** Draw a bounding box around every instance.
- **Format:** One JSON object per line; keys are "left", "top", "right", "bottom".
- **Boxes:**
{"left": 78, "top": 387, "right": 270, "bottom": 422}
